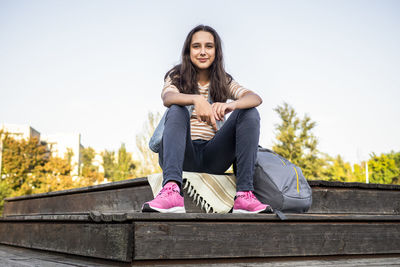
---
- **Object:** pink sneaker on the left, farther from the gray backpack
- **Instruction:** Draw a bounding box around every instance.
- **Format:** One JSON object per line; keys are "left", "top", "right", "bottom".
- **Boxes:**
{"left": 142, "top": 182, "right": 186, "bottom": 213}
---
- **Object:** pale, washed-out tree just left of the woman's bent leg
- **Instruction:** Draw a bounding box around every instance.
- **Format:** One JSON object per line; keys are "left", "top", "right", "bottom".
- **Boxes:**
{"left": 136, "top": 112, "right": 162, "bottom": 177}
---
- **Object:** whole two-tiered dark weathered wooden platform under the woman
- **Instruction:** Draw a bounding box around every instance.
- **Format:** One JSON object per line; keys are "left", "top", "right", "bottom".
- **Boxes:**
{"left": 0, "top": 178, "right": 400, "bottom": 262}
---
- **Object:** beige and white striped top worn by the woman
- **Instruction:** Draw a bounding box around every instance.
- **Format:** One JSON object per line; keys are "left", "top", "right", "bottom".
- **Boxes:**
{"left": 161, "top": 77, "right": 251, "bottom": 140}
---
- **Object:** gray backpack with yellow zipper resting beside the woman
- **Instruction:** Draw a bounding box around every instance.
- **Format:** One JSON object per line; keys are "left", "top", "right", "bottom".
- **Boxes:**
{"left": 254, "top": 147, "right": 312, "bottom": 219}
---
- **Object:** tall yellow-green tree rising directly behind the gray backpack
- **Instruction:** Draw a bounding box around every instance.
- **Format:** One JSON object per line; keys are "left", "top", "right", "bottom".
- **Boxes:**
{"left": 272, "top": 103, "right": 326, "bottom": 178}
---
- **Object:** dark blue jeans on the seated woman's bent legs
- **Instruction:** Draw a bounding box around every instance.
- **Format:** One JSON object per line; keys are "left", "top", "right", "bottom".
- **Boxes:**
{"left": 159, "top": 105, "right": 260, "bottom": 191}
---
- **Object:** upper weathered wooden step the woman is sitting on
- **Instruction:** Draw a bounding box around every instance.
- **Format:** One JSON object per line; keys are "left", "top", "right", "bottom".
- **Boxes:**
{"left": 3, "top": 178, "right": 400, "bottom": 217}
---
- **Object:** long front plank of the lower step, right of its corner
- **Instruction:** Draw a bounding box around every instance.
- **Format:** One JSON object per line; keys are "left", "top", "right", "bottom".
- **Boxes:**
{"left": 133, "top": 222, "right": 400, "bottom": 260}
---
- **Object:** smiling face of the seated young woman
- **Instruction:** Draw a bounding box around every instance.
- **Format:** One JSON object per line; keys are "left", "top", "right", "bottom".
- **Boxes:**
{"left": 190, "top": 31, "right": 215, "bottom": 70}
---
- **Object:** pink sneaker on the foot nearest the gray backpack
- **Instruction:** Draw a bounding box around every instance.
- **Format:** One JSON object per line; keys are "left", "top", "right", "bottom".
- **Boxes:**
{"left": 232, "top": 191, "right": 273, "bottom": 213}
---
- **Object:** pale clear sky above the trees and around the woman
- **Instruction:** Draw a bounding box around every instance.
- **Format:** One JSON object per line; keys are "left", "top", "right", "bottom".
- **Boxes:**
{"left": 0, "top": 0, "right": 400, "bottom": 163}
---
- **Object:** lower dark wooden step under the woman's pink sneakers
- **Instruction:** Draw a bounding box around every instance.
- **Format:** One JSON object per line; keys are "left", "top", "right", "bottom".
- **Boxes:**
{"left": 0, "top": 211, "right": 400, "bottom": 262}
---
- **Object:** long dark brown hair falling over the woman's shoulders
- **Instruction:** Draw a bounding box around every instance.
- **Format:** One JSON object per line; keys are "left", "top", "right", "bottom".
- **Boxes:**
{"left": 164, "top": 25, "right": 233, "bottom": 102}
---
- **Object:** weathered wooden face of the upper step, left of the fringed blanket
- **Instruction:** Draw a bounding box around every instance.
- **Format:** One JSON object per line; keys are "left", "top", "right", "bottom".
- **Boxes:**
{"left": 3, "top": 179, "right": 202, "bottom": 217}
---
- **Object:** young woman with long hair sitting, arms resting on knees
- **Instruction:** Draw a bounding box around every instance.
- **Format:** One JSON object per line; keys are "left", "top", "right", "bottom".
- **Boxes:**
{"left": 142, "top": 25, "right": 272, "bottom": 213}
